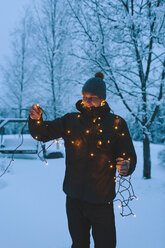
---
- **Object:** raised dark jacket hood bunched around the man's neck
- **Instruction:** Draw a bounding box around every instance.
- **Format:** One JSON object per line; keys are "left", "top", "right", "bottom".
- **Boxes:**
{"left": 76, "top": 100, "right": 111, "bottom": 118}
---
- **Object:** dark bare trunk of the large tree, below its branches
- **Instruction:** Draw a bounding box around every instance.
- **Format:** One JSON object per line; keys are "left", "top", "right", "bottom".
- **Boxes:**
{"left": 143, "top": 134, "right": 151, "bottom": 179}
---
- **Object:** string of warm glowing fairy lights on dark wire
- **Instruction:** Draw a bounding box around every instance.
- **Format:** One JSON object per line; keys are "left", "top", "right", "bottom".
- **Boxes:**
{"left": 0, "top": 105, "right": 138, "bottom": 217}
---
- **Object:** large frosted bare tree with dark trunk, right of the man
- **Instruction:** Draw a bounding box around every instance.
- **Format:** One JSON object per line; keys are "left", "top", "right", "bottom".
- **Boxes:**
{"left": 67, "top": 0, "right": 165, "bottom": 178}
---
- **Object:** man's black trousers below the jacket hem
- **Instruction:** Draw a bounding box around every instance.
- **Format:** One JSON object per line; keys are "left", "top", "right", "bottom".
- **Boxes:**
{"left": 66, "top": 196, "right": 116, "bottom": 248}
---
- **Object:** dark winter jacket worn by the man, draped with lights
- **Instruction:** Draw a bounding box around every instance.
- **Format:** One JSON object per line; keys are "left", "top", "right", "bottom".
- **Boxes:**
{"left": 29, "top": 100, "right": 136, "bottom": 203}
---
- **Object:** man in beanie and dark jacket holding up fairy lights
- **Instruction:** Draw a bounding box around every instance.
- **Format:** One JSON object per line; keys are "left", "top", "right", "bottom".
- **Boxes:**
{"left": 29, "top": 72, "right": 136, "bottom": 248}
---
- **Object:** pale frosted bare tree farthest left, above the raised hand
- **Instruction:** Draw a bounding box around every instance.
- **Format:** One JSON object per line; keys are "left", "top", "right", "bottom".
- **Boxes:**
{"left": 0, "top": 9, "right": 36, "bottom": 118}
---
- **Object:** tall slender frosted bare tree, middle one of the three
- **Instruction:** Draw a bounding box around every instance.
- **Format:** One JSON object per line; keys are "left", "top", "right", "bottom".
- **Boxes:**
{"left": 34, "top": 0, "right": 71, "bottom": 118}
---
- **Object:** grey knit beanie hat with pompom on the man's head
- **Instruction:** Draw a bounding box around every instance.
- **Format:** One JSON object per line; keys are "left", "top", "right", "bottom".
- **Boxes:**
{"left": 82, "top": 72, "right": 106, "bottom": 100}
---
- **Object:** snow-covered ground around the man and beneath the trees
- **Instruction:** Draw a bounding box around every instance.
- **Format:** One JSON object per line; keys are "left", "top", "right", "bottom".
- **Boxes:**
{"left": 0, "top": 138, "right": 165, "bottom": 248}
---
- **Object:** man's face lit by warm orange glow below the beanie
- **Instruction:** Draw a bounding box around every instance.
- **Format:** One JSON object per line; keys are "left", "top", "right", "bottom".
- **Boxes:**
{"left": 82, "top": 92, "right": 103, "bottom": 108}
